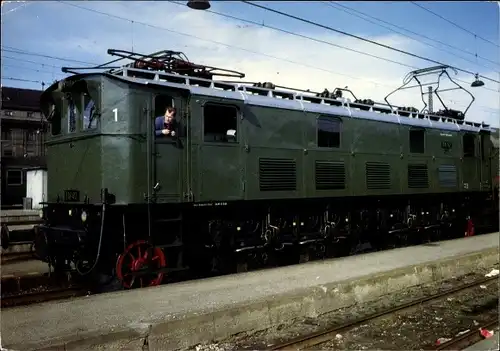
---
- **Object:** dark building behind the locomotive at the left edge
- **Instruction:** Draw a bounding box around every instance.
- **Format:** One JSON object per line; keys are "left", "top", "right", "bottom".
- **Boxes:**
{"left": 0, "top": 87, "right": 46, "bottom": 208}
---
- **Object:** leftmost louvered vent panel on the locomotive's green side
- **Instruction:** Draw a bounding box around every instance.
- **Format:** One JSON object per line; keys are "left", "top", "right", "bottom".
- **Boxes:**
{"left": 259, "top": 158, "right": 297, "bottom": 191}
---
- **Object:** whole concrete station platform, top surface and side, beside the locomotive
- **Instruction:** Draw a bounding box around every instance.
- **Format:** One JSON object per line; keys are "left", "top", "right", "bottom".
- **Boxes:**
{"left": 1, "top": 233, "right": 500, "bottom": 350}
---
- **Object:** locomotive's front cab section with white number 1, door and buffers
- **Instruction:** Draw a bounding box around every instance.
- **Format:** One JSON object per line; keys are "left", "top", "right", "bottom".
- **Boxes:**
{"left": 35, "top": 74, "right": 187, "bottom": 271}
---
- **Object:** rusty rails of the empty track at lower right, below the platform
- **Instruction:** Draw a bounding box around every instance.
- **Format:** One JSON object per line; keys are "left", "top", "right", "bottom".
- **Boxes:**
{"left": 267, "top": 276, "right": 498, "bottom": 351}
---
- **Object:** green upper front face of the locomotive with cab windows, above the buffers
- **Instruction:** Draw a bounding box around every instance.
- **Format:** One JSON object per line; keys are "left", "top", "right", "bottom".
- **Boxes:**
{"left": 41, "top": 76, "right": 102, "bottom": 203}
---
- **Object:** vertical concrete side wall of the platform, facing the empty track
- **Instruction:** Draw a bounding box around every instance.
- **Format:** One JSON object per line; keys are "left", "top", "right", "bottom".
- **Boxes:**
{"left": 8, "top": 247, "right": 499, "bottom": 350}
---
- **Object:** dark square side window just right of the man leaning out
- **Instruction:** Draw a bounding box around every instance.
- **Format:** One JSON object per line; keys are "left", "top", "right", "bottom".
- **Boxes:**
{"left": 203, "top": 103, "right": 238, "bottom": 143}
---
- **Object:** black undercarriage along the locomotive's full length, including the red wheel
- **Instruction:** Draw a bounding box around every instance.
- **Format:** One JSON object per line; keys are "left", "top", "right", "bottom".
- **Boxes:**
{"left": 36, "top": 193, "right": 498, "bottom": 288}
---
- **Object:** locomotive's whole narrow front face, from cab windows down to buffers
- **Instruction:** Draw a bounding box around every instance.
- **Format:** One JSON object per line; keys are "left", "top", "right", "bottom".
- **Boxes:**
{"left": 35, "top": 75, "right": 103, "bottom": 267}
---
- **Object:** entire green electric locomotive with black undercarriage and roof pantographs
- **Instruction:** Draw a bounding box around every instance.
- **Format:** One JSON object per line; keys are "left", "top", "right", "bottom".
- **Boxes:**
{"left": 36, "top": 49, "right": 499, "bottom": 288}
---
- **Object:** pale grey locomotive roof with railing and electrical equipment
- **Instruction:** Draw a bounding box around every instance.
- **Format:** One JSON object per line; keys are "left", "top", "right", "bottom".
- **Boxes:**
{"left": 43, "top": 49, "right": 498, "bottom": 133}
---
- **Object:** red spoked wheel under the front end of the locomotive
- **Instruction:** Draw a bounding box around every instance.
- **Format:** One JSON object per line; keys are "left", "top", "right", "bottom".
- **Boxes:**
{"left": 116, "top": 240, "right": 167, "bottom": 289}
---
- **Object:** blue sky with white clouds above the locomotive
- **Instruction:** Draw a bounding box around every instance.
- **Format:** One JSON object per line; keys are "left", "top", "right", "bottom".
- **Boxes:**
{"left": 1, "top": 1, "right": 500, "bottom": 127}
